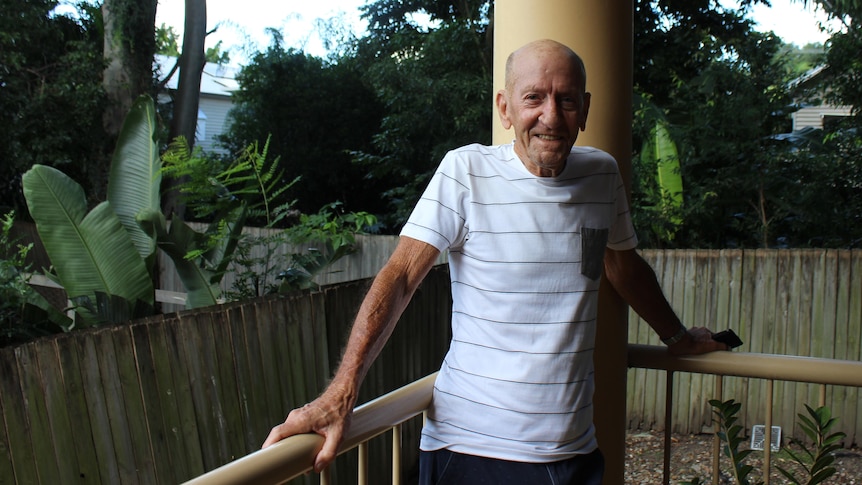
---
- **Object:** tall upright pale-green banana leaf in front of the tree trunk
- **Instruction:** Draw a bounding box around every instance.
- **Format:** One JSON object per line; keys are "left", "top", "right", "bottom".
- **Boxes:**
{"left": 108, "top": 95, "right": 162, "bottom": 260}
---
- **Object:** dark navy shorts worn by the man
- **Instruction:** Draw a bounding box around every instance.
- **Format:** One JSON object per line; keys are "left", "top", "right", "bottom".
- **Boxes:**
{"left": 419, "top": 450, "right": 605, "bottom": 485}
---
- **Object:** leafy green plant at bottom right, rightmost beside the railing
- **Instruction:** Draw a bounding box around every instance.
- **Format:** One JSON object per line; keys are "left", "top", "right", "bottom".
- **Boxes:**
{"left": 777, "top": 405, "right": 847, "bottom": 485}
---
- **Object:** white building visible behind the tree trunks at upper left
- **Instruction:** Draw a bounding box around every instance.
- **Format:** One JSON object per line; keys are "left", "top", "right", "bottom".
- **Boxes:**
{"left": 156, "top": 55, "right": 239, "bottom": 154}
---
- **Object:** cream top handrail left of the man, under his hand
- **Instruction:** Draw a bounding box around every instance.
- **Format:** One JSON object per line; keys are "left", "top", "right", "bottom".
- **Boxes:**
{"left": 186, "top": 373, "right": 437, "bottom": 485}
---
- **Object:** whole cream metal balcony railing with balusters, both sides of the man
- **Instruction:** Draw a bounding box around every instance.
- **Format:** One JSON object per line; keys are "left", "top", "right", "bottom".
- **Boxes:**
{"left": 182, "top": 345, "right": 862, "bottom": 485}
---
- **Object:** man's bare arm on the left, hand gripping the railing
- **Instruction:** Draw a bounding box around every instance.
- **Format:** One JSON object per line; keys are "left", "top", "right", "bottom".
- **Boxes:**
{"left": 263, "top": 236, "right": 440, "bottom": 472}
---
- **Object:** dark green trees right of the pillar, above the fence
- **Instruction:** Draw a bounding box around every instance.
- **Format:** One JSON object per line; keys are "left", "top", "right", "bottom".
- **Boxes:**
{"left": 633, "top": 1, "right": 862, "bottom": 248}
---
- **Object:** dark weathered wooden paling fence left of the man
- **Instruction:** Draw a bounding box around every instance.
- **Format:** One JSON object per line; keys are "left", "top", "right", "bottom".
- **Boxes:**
{"left": 0, "top": 267, "right": 451, "bottom": 485}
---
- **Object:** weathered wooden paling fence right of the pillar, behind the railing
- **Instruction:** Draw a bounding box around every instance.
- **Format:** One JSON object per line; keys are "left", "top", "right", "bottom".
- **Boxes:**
{"left": 627, "top": 250, "right": 862, "bottom": 444}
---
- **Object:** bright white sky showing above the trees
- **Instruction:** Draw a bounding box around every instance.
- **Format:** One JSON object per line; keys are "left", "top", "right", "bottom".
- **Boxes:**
{"left": 156, "top": 0, "right": 840, "bottom": 65}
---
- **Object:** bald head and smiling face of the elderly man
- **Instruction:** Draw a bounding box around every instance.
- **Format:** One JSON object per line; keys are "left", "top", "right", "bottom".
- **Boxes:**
{"left": 497, "top": 41, "right": 590, "bottom": 177}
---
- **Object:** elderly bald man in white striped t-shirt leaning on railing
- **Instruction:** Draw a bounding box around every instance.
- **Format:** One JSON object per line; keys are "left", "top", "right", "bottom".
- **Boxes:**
{"left": 264, "top": 40, "right": 727, "bottom": 485}
